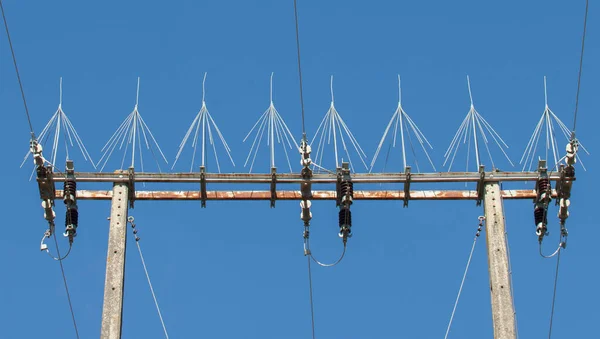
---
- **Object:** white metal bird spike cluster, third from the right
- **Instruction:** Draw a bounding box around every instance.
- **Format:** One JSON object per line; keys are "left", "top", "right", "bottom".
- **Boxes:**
{"left": 369, "top": 75, "right": 436, "bottom": 172}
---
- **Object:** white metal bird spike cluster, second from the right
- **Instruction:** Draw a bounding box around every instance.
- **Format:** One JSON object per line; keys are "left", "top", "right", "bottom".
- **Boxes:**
{"left": 443, "top": 75, "right": 514, "bottom": 172}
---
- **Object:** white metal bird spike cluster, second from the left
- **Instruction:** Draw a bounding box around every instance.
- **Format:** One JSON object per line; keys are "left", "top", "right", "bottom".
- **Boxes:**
{"left": 98, "top": 77, "right": 168, "bottom": 172}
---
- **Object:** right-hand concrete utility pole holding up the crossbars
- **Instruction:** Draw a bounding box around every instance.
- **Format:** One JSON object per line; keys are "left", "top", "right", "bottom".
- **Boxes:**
{"left": 484, "top": 182, "right": 516, "bottom": 339}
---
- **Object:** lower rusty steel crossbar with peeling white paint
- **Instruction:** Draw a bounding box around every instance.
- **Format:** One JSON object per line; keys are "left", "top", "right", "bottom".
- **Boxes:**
{"left": 56, "top": 190, "right": 556, "bottom": 200}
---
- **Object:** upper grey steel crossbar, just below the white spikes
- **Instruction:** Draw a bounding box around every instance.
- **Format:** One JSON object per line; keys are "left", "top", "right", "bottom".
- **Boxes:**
{"left": 49, "top": 172, "right": 560, "bottom": 184}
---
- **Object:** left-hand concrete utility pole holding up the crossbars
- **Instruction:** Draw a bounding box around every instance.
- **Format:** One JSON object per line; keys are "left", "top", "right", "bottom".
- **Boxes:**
{"left": 100, "top": 183, "right": 129, "bottom": 339}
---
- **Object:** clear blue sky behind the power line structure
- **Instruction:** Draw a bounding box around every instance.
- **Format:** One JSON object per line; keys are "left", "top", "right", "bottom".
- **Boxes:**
{"left": 0, "top": 0, "right": 600, "bottom": 339}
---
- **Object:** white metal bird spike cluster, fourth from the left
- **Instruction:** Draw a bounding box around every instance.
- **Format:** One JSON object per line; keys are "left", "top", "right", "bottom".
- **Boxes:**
{"left": 244, "top": 73, "right": 298, "bottom": 173}
